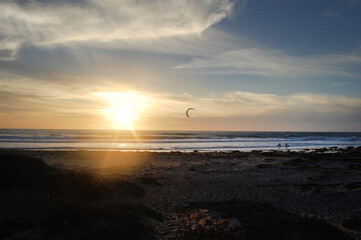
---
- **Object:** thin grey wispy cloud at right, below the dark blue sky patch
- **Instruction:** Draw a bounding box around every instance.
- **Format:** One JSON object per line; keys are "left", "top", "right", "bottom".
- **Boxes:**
{"left": 175, "top": 48, "right": 361, "bottom": 78}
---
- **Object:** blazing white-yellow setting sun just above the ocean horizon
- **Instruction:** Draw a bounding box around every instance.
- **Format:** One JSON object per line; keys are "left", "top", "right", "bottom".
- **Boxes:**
{"left": 98, "top": 92, "right": 150, "bottom": 130}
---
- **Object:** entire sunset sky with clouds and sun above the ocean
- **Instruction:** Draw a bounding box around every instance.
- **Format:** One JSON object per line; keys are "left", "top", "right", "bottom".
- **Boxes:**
{"left": 0, "top": 0, "right": 361, "bottom": 131}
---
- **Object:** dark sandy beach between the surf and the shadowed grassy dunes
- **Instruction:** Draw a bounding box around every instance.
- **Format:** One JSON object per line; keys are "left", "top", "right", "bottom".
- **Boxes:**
{"left": 2, "top": 147, "right": 361, "bottom": 239}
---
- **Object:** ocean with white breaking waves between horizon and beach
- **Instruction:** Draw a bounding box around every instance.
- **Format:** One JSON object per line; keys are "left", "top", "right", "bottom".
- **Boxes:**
{"left": 0, "top": 129, "right": 361, "bottom": 152}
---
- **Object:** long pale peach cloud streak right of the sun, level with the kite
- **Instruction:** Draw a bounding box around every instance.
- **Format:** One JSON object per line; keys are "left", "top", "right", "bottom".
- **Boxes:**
{"left": 153, "top": 91, "right": 361, "bottom": 117}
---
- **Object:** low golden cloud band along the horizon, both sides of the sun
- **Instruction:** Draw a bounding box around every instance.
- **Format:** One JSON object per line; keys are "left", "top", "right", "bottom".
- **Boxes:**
{"left": 0, "top": 88, "right": 361, "bottom": 131}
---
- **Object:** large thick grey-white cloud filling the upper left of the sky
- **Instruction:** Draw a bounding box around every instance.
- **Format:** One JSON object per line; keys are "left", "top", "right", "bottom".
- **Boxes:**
{"left": 0, "top": 0, "right": 233, "bottom": 59}
